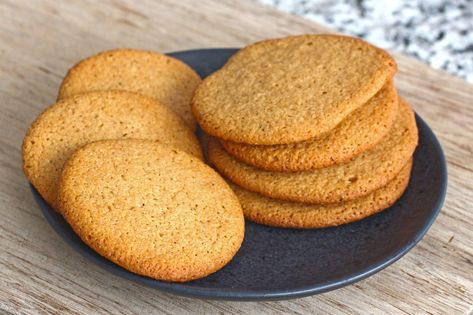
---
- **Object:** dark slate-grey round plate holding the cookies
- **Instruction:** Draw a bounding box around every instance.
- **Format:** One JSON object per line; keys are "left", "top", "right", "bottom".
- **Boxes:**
{"left": 32, "top": 49, "right": 447, "bottom": 300}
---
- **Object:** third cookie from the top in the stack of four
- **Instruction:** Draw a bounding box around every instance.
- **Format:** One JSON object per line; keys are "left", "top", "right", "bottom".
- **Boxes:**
{"left": 208, "top": 101, "right": 418, "bottom": 203}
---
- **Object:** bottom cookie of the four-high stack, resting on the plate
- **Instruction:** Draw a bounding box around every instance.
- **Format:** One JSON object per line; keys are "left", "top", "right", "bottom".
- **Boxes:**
{"left": 230, "top": 159, "right": 412, "bottom": 229}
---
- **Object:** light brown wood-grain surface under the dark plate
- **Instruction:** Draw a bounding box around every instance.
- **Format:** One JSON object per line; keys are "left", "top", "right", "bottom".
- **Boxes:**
{"left": 0, "top": 0, "right": 473, "bottom": 314}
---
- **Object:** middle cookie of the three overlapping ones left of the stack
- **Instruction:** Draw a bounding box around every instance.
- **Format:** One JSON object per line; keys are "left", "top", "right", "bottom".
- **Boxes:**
{"left": 23, "top": 91, "right": 202, "bottom": 208}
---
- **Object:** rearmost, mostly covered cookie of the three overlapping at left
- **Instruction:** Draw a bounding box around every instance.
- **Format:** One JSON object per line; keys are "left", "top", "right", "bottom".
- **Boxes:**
{"left": 58, "top": 49, "right": 201, "bottom": 130}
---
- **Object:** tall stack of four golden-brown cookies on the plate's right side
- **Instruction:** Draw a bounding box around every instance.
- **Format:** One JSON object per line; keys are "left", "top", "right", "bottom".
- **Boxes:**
{"left": 192, "top": 35, "right": 418, "bottom": 228}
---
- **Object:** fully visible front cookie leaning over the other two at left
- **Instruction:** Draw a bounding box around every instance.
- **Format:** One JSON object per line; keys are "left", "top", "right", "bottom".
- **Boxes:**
{"left": 58, "top": 139, "right": 244, "bottom": 282}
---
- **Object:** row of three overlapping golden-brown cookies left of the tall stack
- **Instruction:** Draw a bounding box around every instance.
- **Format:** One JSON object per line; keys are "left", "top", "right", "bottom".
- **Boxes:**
{"left": 23, "top": 50, "right": 244, "bottom": 281}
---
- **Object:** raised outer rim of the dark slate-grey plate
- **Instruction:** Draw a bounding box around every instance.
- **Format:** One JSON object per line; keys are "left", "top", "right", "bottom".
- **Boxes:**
{"left": 29, "top": 48, "right": 448, "bottom": 301}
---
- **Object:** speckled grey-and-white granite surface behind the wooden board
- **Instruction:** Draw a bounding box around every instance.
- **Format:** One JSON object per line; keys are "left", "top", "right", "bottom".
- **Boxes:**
{"left": 256, "top": 0, "right": 473, "bottom": 83}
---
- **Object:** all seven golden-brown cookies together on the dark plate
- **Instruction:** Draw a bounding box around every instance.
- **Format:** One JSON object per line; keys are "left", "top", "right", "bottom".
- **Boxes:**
{"left": 23, "top": 35, "right": 417, "bottom": 281}
